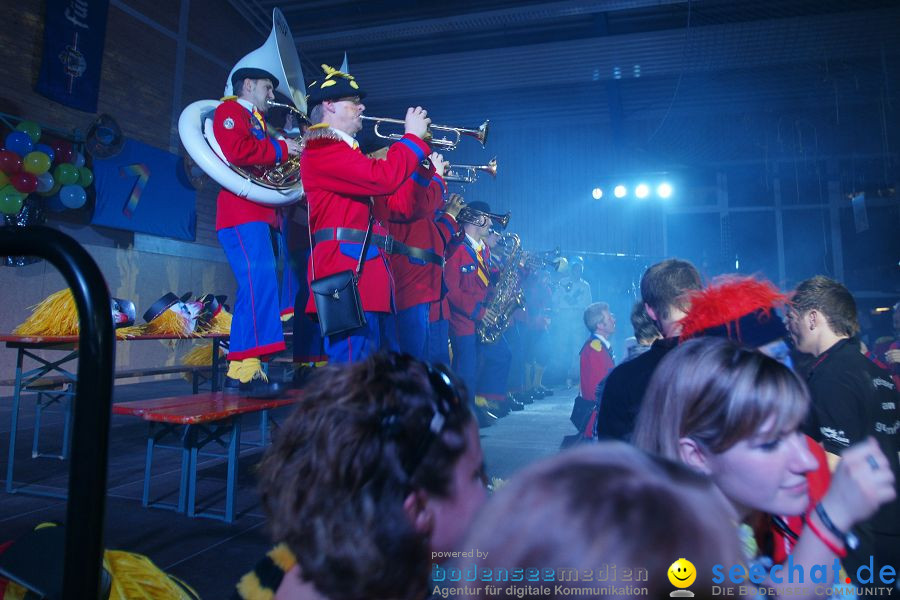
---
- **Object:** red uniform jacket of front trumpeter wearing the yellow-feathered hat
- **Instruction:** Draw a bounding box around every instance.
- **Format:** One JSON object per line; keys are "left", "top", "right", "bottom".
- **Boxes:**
{"left": 300, "top": 127, "right": 430, "bottom": 313}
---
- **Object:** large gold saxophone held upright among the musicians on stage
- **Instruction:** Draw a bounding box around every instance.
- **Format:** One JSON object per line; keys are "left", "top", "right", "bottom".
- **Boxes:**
{"left": 478, "top": 233, "right": 525, "bottom": 344}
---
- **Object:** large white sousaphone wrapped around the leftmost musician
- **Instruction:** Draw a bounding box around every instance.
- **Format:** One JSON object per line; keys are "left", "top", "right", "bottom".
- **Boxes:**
{"left": 178, "top": 8, "right": 306, "bottom": 206}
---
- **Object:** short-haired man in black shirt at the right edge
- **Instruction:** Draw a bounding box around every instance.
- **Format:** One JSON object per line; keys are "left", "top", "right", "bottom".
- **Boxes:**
{"left": 787, "top": 276, "right": 900, "bottom": 585}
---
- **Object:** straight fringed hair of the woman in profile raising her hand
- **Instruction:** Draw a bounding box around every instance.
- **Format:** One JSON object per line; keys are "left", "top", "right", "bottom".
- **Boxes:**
{"left": 633, "top": 337, "right": 809, "bottom": 460}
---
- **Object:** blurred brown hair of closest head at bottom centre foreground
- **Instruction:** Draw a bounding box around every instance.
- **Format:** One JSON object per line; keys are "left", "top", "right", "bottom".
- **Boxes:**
{"left": 457, "top": 442, "right": 741, "bottom": 598}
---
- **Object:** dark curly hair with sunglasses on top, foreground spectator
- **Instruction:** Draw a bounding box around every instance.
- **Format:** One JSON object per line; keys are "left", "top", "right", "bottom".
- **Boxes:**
{"left": 260, "top": 354, "right": 472, "bottom": 600}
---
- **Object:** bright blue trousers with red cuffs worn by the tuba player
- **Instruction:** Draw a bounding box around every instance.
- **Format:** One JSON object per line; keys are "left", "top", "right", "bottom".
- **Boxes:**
{"left": 218, "top": 222, "right": 284, "bottom": 360}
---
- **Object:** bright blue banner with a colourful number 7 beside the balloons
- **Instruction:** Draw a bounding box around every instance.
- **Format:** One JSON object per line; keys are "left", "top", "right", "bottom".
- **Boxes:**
{"left": 91, "top": 140, "right": 197, "bottom": 241}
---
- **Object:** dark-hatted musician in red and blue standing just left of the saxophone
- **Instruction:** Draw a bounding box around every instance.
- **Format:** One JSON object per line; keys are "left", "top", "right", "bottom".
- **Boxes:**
{"left": 444, "top": 201, "right": 497, "bottom": 427}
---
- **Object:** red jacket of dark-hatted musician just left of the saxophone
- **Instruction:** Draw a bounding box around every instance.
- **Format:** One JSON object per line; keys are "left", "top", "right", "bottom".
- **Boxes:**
{"left": 444, "top": 238, "right": 491, "bottom": 335}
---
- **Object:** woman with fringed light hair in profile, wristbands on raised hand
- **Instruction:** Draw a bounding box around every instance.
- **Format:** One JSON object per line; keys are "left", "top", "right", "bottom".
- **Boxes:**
{"left": 634, "top": 337, "right": 895, "bottom": 593}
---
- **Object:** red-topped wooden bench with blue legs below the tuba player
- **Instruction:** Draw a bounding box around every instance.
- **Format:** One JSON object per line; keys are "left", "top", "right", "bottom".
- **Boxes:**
{"left": 112, "top": 390, "right": 302, "bottom": 523}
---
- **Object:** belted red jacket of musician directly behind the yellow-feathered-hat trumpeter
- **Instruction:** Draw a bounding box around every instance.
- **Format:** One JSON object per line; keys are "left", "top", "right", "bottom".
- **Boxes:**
{"left": 386, "top": 172, "right": 459, "bottom": 310}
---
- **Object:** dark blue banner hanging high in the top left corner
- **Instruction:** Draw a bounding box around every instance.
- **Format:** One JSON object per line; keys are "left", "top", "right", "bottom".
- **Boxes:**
{"left": 35, "top": 0, "right": 109, "bottom": 112}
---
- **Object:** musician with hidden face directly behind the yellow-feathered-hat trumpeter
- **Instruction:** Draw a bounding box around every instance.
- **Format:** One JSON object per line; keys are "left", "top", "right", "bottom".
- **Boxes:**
{"left": 386, "top": 152, "right": 462, "bottom": 362}
